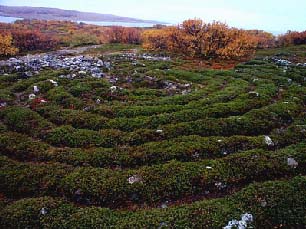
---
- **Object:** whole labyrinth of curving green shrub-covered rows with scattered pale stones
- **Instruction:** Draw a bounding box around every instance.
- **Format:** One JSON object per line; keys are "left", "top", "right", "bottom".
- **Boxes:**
{"left": 0, "top": 47, "right": 306, "bottom": 228}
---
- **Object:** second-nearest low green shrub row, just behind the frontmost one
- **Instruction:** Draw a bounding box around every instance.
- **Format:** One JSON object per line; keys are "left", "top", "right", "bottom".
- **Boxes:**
{"left": 0, "top": 144, "right": 306, "bottom": 206}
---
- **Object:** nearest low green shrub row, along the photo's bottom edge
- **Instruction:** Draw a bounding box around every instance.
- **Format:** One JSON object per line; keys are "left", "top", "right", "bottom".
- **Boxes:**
{"left": 0, "top": 176, "right": 306, "bottom": 229}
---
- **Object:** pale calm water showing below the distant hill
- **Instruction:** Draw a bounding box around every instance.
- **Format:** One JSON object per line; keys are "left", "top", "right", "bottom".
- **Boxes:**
{"left": 0, "top": 16, "right": 158, "bottom": 27}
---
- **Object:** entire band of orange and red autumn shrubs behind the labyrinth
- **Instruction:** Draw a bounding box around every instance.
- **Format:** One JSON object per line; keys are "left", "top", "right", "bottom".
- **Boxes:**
{"left": 0, "top": 19, "right": 306, "bottom": 60}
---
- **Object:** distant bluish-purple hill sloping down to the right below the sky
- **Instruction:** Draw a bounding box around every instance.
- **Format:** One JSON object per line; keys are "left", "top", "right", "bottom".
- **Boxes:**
{"left": 0, "top": 5, "right": 166, "bottom": 24}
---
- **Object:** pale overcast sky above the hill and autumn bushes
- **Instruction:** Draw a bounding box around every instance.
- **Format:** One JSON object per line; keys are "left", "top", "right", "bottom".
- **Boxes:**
{"left": 0, "top": 0, "right": 306, "bottom": 32}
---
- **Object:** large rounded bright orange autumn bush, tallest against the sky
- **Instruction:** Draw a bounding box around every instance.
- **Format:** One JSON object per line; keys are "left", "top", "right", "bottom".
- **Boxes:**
{"left": 142, "top": 19, "right": 258, "bottom": 59}
